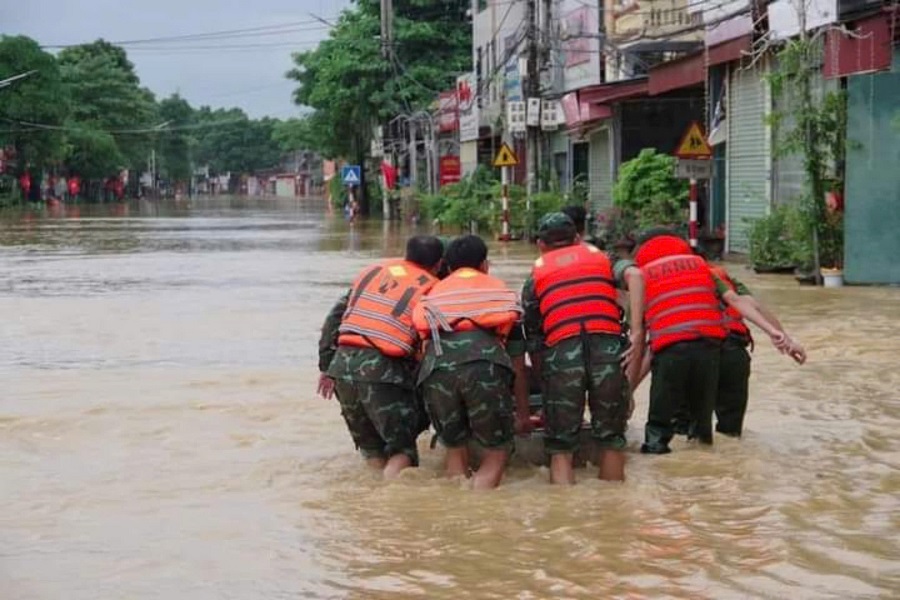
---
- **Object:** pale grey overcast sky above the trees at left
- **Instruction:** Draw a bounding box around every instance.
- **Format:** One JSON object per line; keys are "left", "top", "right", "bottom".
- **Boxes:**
{"left": 0, "top": 0, "right": 349, "bottom": 118}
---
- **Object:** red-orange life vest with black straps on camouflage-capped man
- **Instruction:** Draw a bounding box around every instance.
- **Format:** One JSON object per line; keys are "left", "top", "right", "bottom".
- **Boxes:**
{"left": 531, "top": 244, "right": 622, "bottom": 346}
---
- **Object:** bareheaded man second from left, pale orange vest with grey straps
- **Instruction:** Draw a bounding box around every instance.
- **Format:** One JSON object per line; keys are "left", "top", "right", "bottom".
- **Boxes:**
{"left": 413, "top": 235, "right": 530, "bottom": 489}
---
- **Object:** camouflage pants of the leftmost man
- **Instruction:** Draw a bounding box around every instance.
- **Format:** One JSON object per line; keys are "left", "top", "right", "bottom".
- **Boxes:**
{"left": 335, "top": 379, "right": 420, "bottom": 465}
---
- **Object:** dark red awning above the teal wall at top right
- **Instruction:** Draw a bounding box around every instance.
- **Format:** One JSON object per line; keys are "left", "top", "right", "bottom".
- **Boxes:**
{"left": 822, "top": 13, "right": 892, "bottom": 79}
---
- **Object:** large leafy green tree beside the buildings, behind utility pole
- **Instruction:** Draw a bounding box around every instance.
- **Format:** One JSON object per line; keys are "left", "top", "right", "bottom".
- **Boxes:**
{"left": 287, "top": 0, "right": 471, "bottom": 214}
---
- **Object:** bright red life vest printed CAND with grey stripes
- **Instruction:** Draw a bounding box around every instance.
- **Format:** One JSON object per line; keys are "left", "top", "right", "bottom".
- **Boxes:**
{"left": 635, "top": 236, "right": 728, "bottom": 352}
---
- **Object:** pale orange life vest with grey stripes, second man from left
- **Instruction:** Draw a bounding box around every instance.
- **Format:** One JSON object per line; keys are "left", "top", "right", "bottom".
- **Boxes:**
{"left": 413, "top": 268, "right": 522, "bottom": 356}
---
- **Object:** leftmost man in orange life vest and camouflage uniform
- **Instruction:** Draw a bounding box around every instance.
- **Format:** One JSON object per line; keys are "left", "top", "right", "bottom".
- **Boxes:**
{"left": 318, "top": 236, "right": 443, "bottom": 479}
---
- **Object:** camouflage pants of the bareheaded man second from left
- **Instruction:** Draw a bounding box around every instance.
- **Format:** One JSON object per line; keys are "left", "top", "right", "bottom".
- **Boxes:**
{"left": 422, "top": 360, "right": 515, "bottom": 449}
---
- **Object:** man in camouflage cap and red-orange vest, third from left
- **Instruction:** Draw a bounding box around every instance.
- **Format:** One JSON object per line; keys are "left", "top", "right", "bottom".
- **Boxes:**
{"left": 522, "top": 213, "right": 643, "bottom": 484}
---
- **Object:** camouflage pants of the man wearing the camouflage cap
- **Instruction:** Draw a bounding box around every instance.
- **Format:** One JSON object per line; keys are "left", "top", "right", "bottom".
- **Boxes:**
{"left": 542, "top": 339, "right": 630, "bottom": 454}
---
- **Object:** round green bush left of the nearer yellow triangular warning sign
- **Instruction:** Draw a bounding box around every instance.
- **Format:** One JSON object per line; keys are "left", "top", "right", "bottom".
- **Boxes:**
{"left": 613, "top": 148, "right": 688, "bottom": 228}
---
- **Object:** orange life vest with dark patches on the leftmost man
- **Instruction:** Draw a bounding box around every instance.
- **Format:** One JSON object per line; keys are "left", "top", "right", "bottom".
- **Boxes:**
{"left": 338, "top": 258, "right": 437, "bottom": 358}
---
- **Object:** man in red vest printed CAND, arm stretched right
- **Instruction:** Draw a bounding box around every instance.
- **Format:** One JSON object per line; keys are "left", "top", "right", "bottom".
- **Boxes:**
{"left": 635, "top": 231, "right": 797, "bottom": 454}
